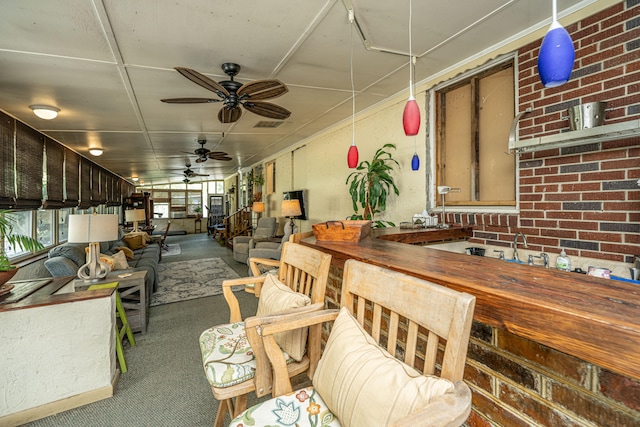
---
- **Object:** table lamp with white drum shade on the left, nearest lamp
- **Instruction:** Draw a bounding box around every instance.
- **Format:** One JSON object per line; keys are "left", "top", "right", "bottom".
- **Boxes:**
{"left": 68, "top": 214, "right": 118, "bottom": 282}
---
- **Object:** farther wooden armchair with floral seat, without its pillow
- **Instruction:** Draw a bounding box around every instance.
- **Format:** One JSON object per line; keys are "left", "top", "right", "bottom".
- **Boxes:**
{"left": 200, "top": 242, "right": 331, "bottom": 427}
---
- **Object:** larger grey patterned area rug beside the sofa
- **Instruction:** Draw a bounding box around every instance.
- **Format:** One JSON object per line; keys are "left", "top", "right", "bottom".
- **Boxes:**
{"left": 151, "top": 258, "right": 244, "bottom": 307}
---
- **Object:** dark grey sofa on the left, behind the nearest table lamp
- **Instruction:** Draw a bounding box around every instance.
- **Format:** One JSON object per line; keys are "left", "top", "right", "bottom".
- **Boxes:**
{"left": 44, "top": 230, "right": 161, "bottom": 301}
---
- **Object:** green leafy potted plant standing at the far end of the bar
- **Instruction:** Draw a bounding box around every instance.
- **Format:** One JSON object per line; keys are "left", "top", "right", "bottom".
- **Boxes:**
{"left": 346, "top": 144, "right": 400, "bottom": 227}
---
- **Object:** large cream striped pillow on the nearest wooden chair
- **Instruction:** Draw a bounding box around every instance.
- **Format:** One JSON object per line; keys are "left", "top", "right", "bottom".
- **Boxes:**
{"left": 313, "top": 307, "right": 454, "bottom": 426}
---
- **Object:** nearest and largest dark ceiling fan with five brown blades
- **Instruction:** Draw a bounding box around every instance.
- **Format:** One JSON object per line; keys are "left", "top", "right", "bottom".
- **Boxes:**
{"left": 161, "top": 62, "right": 291, "bottom": 123}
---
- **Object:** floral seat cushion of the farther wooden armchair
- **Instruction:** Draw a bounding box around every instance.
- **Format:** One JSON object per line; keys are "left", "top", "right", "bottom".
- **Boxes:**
{"left": 200, "top": 322, "right": 293, "bottom": 387}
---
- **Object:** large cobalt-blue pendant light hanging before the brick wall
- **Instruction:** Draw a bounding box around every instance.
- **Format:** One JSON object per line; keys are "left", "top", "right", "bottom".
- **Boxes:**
{"left": 538, "top": 0, "right": 576, "bottom": 87}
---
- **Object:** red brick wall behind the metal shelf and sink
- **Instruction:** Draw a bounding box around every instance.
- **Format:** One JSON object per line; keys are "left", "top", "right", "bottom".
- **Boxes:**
{"left": 447, "top": 0, "right": 640, "bottom": 262}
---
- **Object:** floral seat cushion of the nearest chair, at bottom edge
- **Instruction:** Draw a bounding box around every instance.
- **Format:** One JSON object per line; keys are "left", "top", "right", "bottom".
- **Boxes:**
{"left": 229, "top": 387, "right": 342, "bottom": 427}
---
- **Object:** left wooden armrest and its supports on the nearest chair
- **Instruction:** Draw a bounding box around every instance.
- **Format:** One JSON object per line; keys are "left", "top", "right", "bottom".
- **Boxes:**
{"left": 252, "top": 309, "right": 339, "bottom": 397}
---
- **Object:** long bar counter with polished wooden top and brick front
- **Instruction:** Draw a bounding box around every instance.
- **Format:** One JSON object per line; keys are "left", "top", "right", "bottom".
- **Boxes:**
{"left": 301, "top": 227, "right": 640, "bottom": 426}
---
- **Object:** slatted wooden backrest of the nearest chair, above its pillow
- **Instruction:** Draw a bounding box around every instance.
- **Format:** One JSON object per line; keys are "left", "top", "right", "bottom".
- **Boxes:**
{"left": 341, "top": 260, "right": 475, "bottom": 382}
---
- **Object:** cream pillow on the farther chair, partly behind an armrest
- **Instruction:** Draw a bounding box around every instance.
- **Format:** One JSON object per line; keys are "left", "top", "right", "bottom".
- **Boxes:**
{"left": 256, "top": 274, "right": 311, "bottom": 362}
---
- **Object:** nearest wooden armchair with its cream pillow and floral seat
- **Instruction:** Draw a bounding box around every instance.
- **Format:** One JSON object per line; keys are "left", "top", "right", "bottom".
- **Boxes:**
{"left": 230, "top": 260, "right": 475, "bottom": 427}
